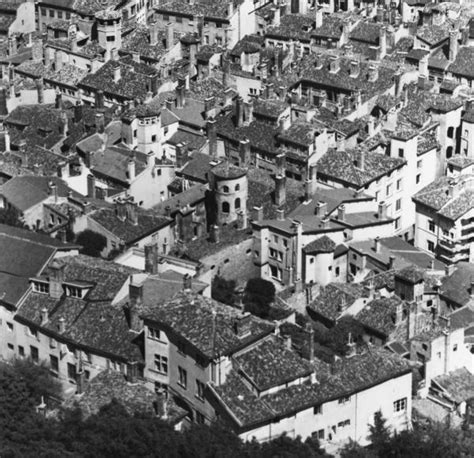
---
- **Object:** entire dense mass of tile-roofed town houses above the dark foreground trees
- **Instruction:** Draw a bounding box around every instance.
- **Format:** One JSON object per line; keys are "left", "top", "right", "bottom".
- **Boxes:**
{"left": 0, "top": 0, "right": 474, "bottom": 451}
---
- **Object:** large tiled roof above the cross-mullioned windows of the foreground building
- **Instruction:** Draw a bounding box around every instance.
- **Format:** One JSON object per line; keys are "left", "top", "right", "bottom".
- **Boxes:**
{"left": 143, "top": 292, "right": 273, "bottom": 359}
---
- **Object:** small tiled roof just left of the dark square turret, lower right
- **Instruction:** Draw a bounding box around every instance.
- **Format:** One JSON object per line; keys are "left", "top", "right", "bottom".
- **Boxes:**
{"left": 356, "top": 296, "right": 406, "bottom": 337}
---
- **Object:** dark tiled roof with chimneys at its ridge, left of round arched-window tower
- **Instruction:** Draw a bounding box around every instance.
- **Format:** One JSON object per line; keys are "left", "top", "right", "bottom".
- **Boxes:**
{"left": 89, "top": 208, "right": 172, "bottom": 245}
